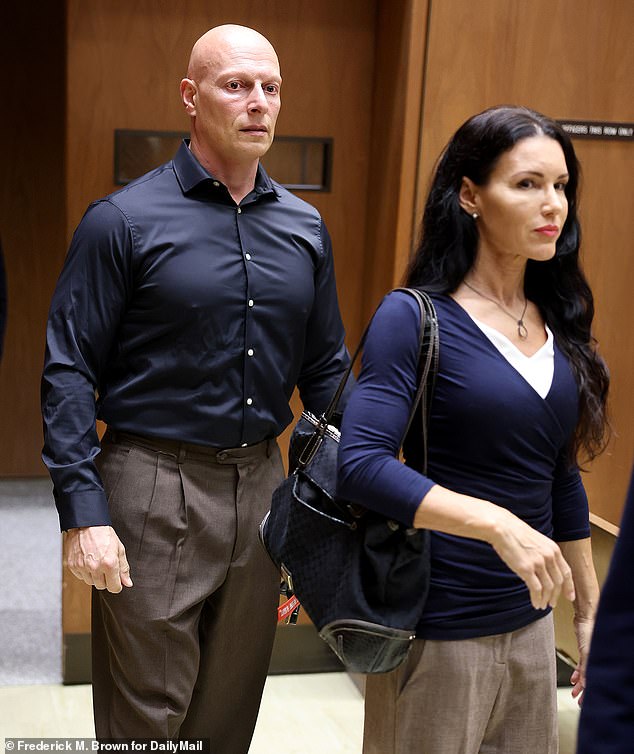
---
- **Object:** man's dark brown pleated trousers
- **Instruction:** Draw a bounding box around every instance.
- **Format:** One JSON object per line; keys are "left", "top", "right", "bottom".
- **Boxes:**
{"left": 92, "top": 433, "right": 284, "bottom": 754}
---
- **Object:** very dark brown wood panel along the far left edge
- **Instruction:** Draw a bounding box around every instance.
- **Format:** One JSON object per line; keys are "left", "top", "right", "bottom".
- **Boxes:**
{"left": 0, "top": 0, "right": 65, "bottom": 477}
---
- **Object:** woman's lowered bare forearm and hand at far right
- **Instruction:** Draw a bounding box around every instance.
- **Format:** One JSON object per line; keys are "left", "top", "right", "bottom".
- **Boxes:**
{"left": 559, "top": 537, "right": 599, "bottom": 705}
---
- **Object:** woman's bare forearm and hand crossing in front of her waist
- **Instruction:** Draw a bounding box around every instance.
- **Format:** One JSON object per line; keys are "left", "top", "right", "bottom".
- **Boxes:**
{"left": 414, "top": 485, "right": 575, "bottom": 610}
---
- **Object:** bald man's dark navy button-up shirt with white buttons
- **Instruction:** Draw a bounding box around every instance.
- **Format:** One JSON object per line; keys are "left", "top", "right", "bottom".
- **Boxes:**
{"left": 42, "top": 143, "right": 349, "bottom": 529}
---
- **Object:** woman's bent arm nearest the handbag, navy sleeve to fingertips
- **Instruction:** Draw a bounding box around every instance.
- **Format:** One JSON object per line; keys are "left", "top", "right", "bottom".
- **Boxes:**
{"left": 337, "top": 293, "right": 574, "bottom": 609}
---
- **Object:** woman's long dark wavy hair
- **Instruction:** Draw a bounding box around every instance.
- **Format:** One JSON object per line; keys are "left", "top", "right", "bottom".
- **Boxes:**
{"left": 405, "top": 106, "right": 609, "bottom": 462}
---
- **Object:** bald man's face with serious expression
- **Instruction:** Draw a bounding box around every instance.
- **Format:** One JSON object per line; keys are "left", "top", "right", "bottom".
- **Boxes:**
{"left": 186, "top": 35, "right": 282, "bottom": 166}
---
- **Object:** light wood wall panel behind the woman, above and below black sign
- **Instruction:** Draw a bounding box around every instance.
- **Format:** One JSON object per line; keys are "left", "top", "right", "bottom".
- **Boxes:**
{"left": 412, "top": 0, "right": 634, "bottom": 524}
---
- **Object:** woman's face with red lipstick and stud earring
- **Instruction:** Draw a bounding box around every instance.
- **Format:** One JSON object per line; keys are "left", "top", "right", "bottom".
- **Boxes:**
{"left": 461, "top": 135, "right": 568, "bottom": 261}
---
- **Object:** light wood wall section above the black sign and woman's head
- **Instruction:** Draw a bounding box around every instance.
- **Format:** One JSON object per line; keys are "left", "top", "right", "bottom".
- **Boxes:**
{"left": 417, "top": 0, "right": 634, "bottom": 216}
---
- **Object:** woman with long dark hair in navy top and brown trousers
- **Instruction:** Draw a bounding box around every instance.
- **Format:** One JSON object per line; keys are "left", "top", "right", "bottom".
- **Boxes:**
{"left": 338, "top": 106, "right": 608, "bottom": 754}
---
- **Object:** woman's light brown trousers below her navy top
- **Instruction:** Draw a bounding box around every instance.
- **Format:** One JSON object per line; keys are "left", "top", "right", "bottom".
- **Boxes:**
{"left": 363, "top": 615, "right": 558, "bottom": 754}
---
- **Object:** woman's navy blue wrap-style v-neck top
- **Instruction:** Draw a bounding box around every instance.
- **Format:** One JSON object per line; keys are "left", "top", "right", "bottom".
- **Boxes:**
{"left": 338, "top": 291, "right": 590, "bottom": 639}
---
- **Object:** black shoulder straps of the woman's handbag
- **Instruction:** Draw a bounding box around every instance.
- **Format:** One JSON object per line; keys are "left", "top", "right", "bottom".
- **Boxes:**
{"left": 298, "top": 288, "right": 439, "bottom": 473}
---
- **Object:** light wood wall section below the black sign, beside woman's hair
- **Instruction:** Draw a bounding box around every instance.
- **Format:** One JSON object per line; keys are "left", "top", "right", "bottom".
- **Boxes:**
{"left": 575, "top": 138, "right": 634, "bottom": 525}
